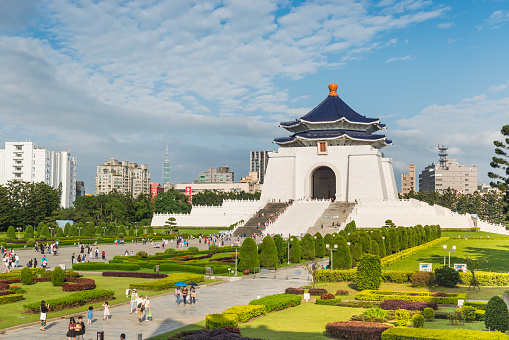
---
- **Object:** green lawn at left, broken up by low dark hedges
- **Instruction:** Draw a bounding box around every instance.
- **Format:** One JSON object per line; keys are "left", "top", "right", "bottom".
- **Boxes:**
{"left": 0, "top": 275, "right": 185, "bottom": 329}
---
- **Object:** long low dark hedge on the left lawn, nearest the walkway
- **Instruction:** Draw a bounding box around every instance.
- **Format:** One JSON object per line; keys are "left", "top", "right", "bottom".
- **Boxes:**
{"left": 23, "top": 289, "right": 115, "bottom": 313}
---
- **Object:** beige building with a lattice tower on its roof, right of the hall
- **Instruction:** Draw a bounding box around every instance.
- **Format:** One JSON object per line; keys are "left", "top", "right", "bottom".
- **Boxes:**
{"left": 419, "top": 145, "right": 477, "bottom": 194}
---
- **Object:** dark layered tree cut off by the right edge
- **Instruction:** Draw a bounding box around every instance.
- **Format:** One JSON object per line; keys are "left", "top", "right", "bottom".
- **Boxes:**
{"left": 488, "top": 125, "right": 509, "bottom": 221}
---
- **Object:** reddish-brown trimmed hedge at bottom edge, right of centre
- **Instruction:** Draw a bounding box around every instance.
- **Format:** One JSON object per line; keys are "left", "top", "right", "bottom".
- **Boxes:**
{"left": 325, "top": 321, "right": 393, "bottom": 340}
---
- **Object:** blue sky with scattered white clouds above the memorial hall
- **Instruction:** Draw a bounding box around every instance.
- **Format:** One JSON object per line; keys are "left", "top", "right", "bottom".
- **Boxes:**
{"left": 0, "top": 0, "right": 509, "bottom": 193}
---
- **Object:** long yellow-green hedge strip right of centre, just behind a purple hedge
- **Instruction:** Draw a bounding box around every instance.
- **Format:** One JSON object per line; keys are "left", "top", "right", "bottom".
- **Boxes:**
{"left": 355, "top": 290, "right": 466, "bottom": 305}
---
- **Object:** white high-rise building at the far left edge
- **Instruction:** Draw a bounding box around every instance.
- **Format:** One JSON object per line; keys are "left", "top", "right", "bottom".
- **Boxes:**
{"left": 0, "top": 142, "right": 76, "bottom": 208}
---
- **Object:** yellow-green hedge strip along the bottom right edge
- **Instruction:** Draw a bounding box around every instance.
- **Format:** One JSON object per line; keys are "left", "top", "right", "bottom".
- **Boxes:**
{"left": 382, "top": 327, "right": 507, "bottom": 340}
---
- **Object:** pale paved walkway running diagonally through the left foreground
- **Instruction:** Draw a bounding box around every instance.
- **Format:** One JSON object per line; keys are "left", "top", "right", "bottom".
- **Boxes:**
{"left": 0, "top": 268, "right": 309, "bottom": 340}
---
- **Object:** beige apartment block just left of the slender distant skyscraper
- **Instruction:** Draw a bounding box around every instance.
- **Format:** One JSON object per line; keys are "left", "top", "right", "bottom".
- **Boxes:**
{"left": 95, "top": 158, "right": 150, "bottom": 197}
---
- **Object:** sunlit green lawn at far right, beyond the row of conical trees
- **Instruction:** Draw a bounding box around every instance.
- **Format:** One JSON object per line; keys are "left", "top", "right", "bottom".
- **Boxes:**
{"left": 384, "top": 238, "right": 509, "bottom": 273}
